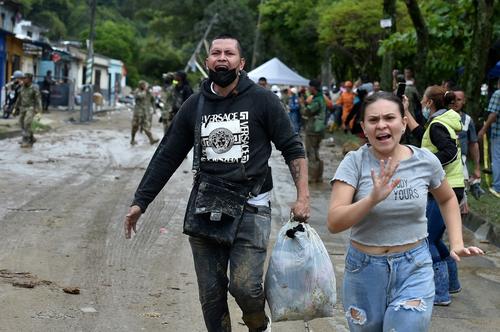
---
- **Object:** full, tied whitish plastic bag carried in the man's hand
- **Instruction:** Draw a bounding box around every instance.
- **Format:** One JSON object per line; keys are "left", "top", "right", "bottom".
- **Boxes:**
{"left": 265, "top": 221, "right": 337, "bottom": 322}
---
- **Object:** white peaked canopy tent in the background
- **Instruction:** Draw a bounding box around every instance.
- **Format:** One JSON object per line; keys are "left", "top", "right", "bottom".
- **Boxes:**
{"left": 248, "top": 58, "right": 309, "bottom": 86}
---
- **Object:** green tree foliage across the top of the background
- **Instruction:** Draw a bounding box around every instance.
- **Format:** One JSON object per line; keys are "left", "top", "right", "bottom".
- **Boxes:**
{"left": 18, "top": 0, "right": 500, "bottom": 92}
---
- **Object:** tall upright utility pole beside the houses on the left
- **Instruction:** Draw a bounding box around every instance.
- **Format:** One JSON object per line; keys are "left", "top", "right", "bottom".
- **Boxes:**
{"left": 80, "top": 0, "right": 96, "bottom": 122}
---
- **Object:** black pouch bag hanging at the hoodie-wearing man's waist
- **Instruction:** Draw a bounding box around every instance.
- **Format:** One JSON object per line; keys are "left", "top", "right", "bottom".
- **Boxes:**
{"left": 183, "top": 173, "right": 249, "bottom": 245}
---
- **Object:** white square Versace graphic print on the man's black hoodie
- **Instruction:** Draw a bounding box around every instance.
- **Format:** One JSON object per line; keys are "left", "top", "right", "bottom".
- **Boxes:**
{"left": 201, "top": 111, "right": 250, "bottom": 163}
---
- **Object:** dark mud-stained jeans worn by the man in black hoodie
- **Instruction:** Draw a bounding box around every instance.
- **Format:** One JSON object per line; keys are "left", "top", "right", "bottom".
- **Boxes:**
{"left": 189, "top": 206, "right": 271, "bottom": 332}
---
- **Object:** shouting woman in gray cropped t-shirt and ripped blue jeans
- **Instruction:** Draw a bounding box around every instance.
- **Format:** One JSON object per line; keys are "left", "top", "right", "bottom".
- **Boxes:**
{"left": 328, "top": 93, "right": 483, "bottom": 331}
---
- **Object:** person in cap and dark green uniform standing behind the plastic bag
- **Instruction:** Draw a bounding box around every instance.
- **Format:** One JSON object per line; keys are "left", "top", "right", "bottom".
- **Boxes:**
{"left": 302, "top": 79, "right": 326, "bottom": 183}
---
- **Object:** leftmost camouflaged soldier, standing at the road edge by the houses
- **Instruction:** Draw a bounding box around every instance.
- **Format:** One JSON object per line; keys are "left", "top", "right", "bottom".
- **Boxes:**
{"left": 14, "top": 73, "right": 42, "bottom": 148}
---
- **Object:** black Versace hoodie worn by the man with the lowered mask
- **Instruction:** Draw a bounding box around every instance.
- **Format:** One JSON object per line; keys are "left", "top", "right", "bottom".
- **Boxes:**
{"left": 132, "top": 71, "right": 305, "bottom": 212}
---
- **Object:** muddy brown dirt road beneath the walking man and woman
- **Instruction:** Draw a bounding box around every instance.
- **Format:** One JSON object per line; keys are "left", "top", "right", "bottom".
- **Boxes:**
{"left": 0, "top": 110, "right": 500, "bottom": 332}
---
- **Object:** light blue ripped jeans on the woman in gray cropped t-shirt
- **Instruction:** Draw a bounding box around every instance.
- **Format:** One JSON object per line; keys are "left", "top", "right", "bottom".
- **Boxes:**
{"left": 343, "top": 240, "right": 434, "bottom": 332}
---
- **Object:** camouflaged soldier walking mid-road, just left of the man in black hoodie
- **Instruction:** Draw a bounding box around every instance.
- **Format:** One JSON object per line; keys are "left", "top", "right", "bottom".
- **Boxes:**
{"left": 130, "top": 80, "right": 159, "bottom": 145}
